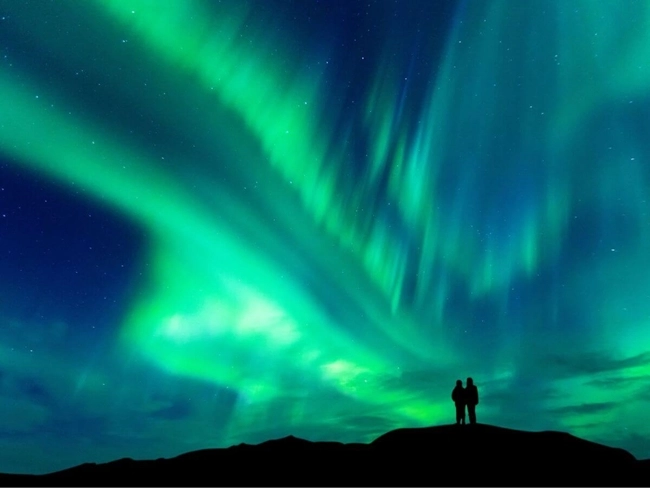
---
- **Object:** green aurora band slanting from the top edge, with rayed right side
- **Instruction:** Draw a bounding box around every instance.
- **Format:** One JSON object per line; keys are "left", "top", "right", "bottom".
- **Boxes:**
{"left": 93, "top": 0, "right": 448, "bottom": 350}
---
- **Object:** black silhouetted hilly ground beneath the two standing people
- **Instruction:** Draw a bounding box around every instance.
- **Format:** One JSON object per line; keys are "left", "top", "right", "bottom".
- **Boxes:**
{"left": 0, "top": 424, "right": 650, "bottom": 486}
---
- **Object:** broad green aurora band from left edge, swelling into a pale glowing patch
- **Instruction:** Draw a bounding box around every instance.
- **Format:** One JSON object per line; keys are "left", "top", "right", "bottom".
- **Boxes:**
{"left": 0, "top": 3, "right": 454, "bottom": 434}
